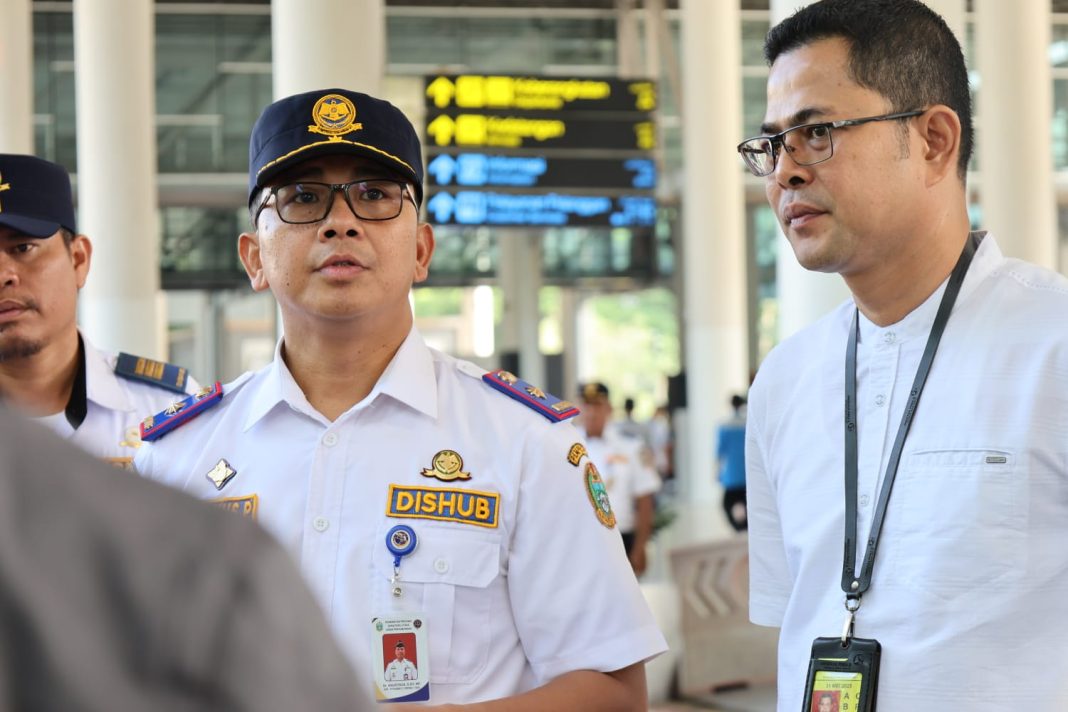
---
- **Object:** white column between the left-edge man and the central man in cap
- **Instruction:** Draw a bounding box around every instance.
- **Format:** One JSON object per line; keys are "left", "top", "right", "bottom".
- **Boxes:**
{"left": 74, "top": 0, "right": 167, "bottom": 359}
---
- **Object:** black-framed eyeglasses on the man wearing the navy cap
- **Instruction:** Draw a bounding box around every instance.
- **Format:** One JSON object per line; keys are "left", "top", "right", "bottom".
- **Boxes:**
{"left": 252, "top": 178, "right": 419, "bottom": 225}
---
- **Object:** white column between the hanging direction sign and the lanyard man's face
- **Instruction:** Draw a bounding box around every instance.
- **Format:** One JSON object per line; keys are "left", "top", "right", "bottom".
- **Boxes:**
{"left": 679, "top": 0, "right": 749, "bottom": 502}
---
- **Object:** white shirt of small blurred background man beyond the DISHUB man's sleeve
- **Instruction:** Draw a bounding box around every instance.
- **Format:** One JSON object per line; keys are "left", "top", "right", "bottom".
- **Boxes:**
{"left": 586, "top": 423, "right": 660, "bottom": 534}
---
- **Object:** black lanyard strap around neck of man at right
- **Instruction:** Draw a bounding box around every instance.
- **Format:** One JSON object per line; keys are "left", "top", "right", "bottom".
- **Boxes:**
{"left": 842, "top": 233, "right": 981, "bottom": 611}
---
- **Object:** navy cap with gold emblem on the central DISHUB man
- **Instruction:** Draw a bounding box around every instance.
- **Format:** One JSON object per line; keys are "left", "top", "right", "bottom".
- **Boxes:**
{"left": 249, "top": 89, "right": 423, "bottom": 205}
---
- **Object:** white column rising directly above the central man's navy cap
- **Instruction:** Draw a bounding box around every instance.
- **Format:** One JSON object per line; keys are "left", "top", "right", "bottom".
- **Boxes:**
{"left": 270, "top": 0, "right": 386, "bottom": 99}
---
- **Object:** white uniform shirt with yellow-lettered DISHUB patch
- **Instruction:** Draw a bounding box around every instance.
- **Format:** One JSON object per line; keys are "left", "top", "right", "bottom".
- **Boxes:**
{"left": 136, "top": 329, "right": 666, "bottom": 703}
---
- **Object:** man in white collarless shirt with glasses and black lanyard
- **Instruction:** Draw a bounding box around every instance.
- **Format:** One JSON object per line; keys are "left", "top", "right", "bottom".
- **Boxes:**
{"left": 739, "top": 0, "right": 1068, "bottom": 712}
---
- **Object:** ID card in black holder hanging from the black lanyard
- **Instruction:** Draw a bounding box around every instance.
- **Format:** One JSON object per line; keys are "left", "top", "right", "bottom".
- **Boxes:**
{"left": 801, "top": 637, "right": 881, "bottom": 712}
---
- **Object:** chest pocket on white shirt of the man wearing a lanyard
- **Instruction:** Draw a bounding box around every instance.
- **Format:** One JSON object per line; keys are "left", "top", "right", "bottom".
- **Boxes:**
{"left": 885, "top": 448, "right": 1028, "bottom": 601}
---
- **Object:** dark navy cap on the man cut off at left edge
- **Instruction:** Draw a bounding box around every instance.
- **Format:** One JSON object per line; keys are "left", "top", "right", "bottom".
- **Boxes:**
{"left": 0, "top": 154, "right": 78, "bottom": 237}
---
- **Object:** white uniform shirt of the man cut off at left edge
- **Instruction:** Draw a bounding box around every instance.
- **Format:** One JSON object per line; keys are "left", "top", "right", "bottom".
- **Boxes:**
{"left": 34, "top": 334, "right": 200, "bottom": 466}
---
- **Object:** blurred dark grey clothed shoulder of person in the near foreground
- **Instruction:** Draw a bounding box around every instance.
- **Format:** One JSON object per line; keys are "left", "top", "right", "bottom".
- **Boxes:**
{"left": 0, "top": 404, "right": 371, "bottom": 712}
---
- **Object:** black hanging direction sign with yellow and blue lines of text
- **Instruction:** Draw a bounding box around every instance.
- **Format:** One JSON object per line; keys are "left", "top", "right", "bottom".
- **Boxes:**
{"left": 424, "top": 75, "right": 657, "bottom": 227}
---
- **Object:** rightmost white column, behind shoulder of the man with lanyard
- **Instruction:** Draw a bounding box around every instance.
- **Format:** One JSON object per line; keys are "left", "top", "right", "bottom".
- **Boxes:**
{"left": 975, "top": 0, "right": 1057, "bottom": 269}
